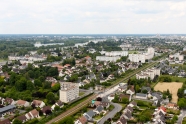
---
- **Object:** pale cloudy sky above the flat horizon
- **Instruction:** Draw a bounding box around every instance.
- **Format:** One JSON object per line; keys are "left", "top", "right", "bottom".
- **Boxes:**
{"left": 0, "top": 0, "right": 186, "bottom": 34}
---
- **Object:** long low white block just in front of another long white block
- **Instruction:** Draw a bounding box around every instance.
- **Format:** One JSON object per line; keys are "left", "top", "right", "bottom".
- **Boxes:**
{"left": 96, "top": 56, "right": 120, "bottom": 62}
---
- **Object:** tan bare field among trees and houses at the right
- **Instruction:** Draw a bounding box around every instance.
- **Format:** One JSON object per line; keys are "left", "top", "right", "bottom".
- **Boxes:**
{"left": 154, "top": 82, "right": 183, "bottom": 103}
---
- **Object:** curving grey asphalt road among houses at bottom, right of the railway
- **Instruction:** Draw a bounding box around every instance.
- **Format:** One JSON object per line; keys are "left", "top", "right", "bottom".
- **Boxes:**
{"left": 97, "top": 97, "right": 122, "bottom": 124}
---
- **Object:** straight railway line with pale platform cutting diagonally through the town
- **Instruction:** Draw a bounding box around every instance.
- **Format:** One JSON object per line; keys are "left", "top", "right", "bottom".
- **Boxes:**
{"left": 46, "top": 62, "right": 157, "bottom": 124}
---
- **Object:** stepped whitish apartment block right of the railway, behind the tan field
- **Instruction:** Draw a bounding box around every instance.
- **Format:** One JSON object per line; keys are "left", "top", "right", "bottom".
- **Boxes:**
{"left": 136, "top": 68, "right": 160, "bottom": 80}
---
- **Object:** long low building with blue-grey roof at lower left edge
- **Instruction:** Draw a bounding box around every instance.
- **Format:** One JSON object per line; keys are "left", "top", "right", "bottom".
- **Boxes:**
{"left": 0, "top": 105, "right": 16, "bottom": 117}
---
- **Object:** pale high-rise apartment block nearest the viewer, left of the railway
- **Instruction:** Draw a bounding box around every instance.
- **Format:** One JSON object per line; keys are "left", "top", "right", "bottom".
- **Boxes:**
{"left": 59, "top": 82, "right": 79, "bottom": 103}
